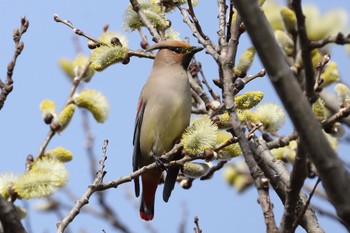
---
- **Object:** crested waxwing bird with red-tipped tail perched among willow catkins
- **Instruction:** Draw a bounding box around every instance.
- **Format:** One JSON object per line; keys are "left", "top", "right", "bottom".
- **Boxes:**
{"left": 132, "top": 41, "right": 203, "bottom": 221}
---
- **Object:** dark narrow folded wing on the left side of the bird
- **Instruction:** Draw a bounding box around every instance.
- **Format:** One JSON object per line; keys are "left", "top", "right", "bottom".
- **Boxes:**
{"left": 132, "top": 98, "right": 145, "bottom": 197}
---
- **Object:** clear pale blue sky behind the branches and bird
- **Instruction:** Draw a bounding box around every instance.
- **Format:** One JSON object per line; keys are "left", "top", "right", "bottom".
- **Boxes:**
{"left": 0, "top": 0, "right": 350, "bottom": 233}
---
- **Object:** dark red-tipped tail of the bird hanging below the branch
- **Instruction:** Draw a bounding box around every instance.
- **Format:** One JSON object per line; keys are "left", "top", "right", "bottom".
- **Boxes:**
{"left": 140, "top": 171, "right": 162, "bottom": 221}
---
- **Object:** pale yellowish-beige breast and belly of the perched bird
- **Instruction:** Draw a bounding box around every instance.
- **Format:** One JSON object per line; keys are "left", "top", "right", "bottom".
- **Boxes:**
{"left": 140, "top": 73, "right": 191, "bottom": 159}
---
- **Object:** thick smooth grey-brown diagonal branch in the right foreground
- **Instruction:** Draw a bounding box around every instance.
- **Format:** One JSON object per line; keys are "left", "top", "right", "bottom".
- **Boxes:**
{"left": 235, "top": 0, "right": 350, "bottom": 228}
